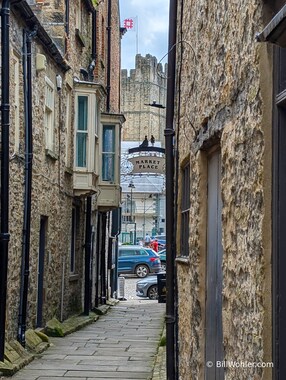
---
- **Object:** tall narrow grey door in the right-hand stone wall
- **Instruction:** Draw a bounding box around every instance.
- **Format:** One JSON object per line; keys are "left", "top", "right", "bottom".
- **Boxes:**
{"left": 205, "top": 150, "right": 224, "bottom": 380}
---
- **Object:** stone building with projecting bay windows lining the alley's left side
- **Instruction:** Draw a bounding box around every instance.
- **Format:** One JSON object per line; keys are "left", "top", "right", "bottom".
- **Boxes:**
{"left": 0, "top": 0, "right": 124, "bottom": 352}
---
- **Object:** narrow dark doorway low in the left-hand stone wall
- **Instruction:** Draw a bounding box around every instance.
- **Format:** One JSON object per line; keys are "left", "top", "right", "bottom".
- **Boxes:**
{"left": 36, "top": 216, "right": 48, "bottom": 327}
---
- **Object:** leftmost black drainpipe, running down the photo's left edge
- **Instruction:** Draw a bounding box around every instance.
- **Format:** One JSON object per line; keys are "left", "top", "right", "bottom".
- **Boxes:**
{"left": 0, "top": 0, "right": 10, "bottom": 361}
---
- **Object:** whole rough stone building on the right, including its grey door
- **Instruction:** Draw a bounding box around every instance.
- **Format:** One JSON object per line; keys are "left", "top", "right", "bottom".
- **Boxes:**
{"left": 170, "top": 0, "right": 286, "bottom": 380}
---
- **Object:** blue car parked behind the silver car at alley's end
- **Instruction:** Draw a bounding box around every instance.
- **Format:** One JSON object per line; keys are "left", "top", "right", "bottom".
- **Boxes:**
{"left": 118, "top": 245, "right": 161, "bottom": 278}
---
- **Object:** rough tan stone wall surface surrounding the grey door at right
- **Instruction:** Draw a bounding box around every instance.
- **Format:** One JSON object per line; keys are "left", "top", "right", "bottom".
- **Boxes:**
{"left": 176, "top": 0, "right": 272, "bottom": 380}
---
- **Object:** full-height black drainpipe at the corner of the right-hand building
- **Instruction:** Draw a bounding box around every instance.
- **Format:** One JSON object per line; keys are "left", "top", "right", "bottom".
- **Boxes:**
{"left": 164, "top": 0, "right": 177, "bottom": 380}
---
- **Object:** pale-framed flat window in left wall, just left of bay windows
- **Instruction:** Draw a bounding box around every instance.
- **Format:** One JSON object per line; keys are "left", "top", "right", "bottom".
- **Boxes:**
{"left": 44, "top": 77, "right": 55, "bottom": 151}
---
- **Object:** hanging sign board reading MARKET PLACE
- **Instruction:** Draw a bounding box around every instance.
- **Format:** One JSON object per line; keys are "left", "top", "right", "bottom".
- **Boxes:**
{"left": 129, "top": 156, "right": 165, "bottom": 174}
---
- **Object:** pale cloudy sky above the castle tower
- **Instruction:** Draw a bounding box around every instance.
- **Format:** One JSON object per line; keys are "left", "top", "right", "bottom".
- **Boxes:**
{"left": 119, "top": 0, "right": 169, "bottom": 70}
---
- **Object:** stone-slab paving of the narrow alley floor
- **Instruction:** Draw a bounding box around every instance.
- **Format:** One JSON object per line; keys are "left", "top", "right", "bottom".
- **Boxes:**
{"left": 3, "top": 301, "right": 165, "bottom": 380}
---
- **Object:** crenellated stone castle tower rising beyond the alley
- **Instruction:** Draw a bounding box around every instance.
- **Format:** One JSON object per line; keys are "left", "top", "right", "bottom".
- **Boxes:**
{"left": 121, "top": 55, "right": 167, "bottom": 145}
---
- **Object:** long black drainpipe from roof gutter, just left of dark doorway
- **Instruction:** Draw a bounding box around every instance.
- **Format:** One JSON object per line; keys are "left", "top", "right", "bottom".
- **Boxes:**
{"left": 17, "top": 26, "right": 37, "bottom": 347}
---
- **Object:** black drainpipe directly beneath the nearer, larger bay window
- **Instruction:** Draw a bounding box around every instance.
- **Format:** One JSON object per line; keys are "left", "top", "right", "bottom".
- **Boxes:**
{"left": 84, "top": 195, "right": 91, "bottom": 315}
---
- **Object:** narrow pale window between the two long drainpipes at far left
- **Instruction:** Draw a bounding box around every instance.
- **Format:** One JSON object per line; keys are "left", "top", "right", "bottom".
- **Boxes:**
{"left": 13, "top": 53, "right": 20, "bottom": 152}
